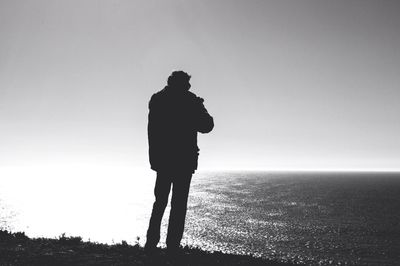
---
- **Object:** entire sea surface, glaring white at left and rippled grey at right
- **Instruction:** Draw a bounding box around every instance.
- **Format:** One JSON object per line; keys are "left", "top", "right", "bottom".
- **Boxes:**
{"left": 0, "top": 170, "right": 400, "bottom": 265}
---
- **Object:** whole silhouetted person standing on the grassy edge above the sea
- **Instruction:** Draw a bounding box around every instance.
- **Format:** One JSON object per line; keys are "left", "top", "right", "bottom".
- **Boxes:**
{"left": 145, "top": 71, "right": 214, "bottom": 252}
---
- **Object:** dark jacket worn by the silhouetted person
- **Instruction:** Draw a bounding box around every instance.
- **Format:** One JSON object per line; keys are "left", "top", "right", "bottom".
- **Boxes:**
{"left": 148, "top": 86, "right": 214, "bottom": 173}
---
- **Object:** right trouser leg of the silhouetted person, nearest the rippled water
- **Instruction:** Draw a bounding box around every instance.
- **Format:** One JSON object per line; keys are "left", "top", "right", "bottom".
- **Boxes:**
{"left": 167, "top": 173, "right": 192, "bottom": 250}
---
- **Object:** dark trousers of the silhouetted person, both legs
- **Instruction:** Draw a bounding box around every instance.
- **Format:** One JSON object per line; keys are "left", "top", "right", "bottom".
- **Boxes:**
{"left": 146, "top": 172, "right": 192, "bottom": 249}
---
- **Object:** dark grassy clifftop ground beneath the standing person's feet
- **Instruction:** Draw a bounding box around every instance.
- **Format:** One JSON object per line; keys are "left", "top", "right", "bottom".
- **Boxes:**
{"left": 0, "top": 230, "right": 292, "bottom": 266}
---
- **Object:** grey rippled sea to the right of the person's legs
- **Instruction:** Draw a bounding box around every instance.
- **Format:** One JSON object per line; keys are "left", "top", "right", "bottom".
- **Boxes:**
{"left": 186, "top": 172, "right": 400, "bottom": 265}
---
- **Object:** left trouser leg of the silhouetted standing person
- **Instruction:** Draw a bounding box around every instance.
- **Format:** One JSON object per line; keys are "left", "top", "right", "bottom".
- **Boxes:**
{"left": 145, "top": 172, "right": 171, "bottom": 249}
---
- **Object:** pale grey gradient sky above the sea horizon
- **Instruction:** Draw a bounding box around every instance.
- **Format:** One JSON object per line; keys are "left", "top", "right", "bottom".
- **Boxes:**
{"left": 0, "top": 0, "right": 400, "bottom": 169}
